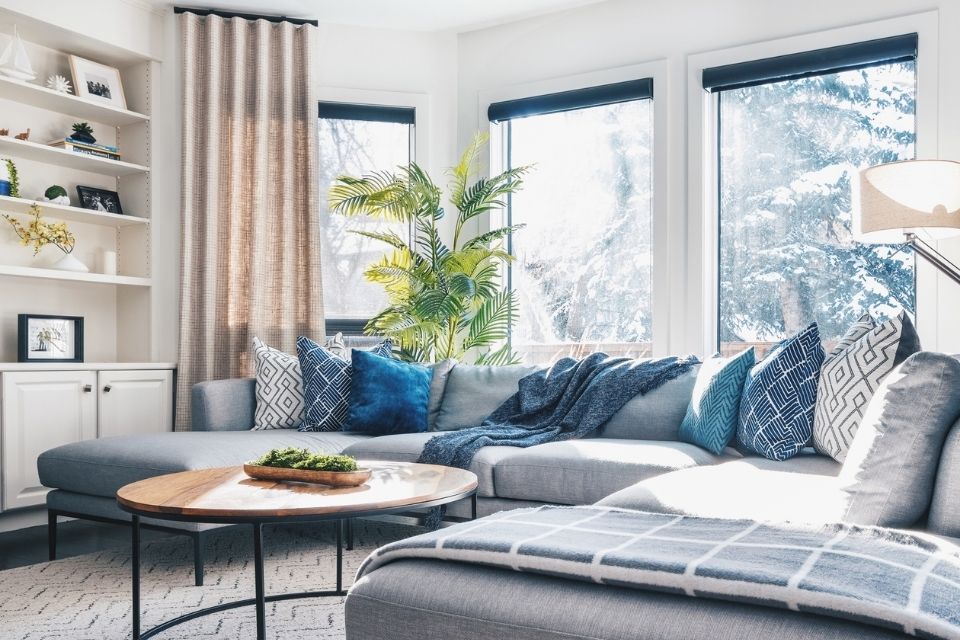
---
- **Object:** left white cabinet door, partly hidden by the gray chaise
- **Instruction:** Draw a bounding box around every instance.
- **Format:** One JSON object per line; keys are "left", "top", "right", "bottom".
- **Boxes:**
{"left": 0, "top": 371, "right": 97, "bottom": 510}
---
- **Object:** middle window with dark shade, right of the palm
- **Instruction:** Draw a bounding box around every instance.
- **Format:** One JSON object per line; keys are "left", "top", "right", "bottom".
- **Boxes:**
{"left": 489, "top": 79, "right": 653, "bottom": 363}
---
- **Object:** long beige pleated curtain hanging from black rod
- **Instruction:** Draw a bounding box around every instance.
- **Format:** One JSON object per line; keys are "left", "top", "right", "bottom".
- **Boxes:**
{"left": 177, "top": 13, "right": 324, "bottom": 430}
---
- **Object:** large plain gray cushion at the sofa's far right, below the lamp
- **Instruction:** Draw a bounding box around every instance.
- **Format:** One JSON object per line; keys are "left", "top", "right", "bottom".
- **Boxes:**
{"left": 839, "top": 351, "right": 960, "bottom": 527}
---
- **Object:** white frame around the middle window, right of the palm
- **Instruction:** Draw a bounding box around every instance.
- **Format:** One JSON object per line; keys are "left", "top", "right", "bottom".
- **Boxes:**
{"left": 473, "top": 60, "right": 673, "bottom": 357}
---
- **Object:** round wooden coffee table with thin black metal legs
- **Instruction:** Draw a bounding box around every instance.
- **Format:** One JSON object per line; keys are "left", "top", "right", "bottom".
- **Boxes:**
{"left": 117, "top": 461, "right": 477, "bottom": 640}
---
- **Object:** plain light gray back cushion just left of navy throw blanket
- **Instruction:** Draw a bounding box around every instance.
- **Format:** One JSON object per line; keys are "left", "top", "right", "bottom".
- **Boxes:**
{"left": 434, "top": 364, "right": 539, "bottom": 431}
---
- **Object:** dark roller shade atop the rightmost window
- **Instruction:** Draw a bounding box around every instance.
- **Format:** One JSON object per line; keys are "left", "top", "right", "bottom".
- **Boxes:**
{"left": 703, "top": 33, "right": 918, "bottom": 92}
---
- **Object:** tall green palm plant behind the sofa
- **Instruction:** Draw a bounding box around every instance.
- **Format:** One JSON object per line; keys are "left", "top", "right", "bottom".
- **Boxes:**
{"left": 330, "top": 135, "right": 529, "bottom": 365}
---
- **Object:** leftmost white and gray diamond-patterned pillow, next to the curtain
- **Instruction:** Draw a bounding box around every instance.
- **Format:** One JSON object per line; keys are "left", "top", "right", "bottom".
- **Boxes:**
{"left": 253, "top": 338, "right": 304, "bottom": 431}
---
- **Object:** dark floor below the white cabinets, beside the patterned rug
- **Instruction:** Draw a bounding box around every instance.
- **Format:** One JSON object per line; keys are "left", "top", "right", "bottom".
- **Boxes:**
{"left": 0, "top": 520, "right": 173, "bottom": 570}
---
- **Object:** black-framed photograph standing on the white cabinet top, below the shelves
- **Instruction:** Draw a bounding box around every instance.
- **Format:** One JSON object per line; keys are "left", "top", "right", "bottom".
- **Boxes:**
{"left": 17, "top": 313, "right": 83, "bottom": 362}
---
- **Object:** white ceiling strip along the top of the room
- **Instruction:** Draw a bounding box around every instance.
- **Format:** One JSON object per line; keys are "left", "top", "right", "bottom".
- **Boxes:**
{"left": 158, "top": 0, "right": 602, "bottom": 32}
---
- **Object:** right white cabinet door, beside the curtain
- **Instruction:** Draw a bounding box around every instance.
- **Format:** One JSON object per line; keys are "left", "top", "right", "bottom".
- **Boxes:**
{"left": 98, "top": 370, "right": 173, "bottom": 438}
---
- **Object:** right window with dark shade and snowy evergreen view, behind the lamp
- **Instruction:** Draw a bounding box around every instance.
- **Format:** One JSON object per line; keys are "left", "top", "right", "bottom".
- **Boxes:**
{"left": 704, "top": 34, "right": 917, "bottom": 353}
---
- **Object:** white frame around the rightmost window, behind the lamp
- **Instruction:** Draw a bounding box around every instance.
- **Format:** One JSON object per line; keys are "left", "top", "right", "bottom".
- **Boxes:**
{"left": 686, "top": 11, "right": 940, "bottom": 354}
